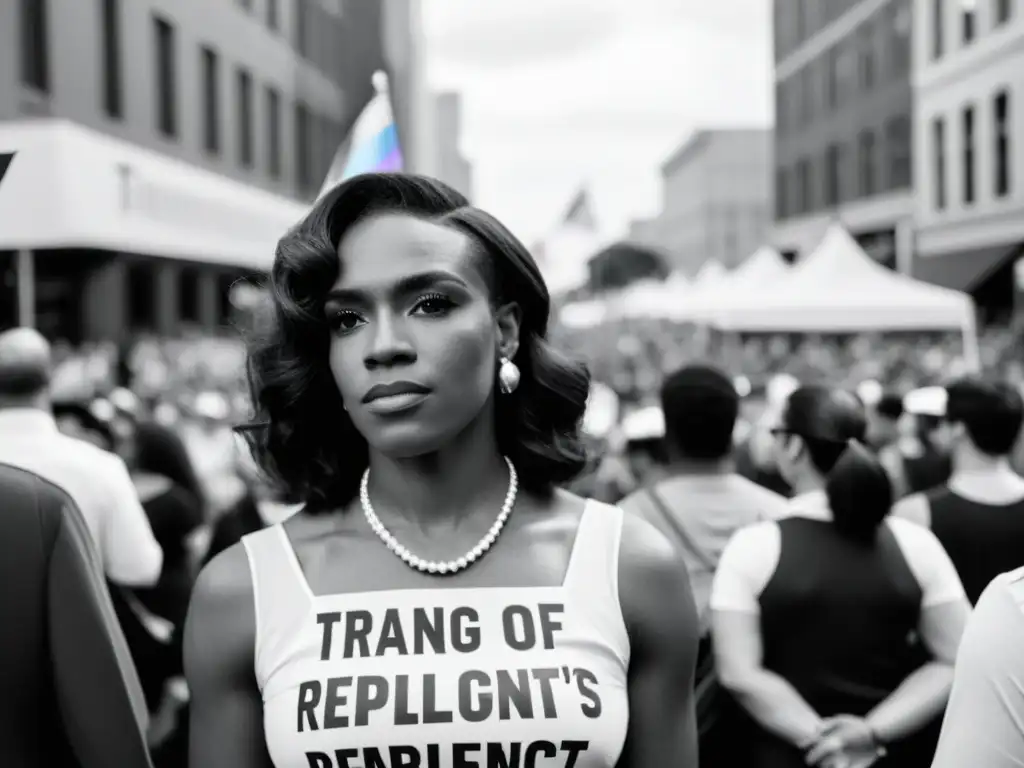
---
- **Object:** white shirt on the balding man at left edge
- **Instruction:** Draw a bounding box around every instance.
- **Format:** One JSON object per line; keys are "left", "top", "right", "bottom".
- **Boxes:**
{"left": 0, "top": 409, "right": 164, "bottom": 587}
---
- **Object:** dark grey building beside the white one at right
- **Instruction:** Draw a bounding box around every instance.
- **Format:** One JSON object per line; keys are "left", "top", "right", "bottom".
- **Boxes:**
{"left": 770, "top": 0, "right": 917, "bottom": 270}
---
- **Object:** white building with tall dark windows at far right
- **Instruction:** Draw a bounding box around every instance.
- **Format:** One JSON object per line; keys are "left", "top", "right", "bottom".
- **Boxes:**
{"left": 913, "top": 0, "right": 1024, "bottom": 319}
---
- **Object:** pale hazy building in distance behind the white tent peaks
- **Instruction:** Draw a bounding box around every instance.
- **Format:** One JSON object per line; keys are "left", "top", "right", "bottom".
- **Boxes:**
{"left": 651, "top": 128, "right": 772, "bottom": 274}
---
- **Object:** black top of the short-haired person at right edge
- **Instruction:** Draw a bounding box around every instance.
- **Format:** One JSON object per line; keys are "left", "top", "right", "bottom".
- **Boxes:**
{"left": 927, "top": 485, "right": 1024, "bottom": 605}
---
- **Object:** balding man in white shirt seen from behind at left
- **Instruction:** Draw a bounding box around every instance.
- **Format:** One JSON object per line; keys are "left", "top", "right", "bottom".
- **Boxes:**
{"left": 0, "top": 328, "right": 164, "bottom": 587}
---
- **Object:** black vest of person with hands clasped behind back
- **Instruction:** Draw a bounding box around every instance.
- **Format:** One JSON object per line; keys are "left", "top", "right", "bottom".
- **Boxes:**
{"left": 750, "top": 517, "right": 932, "bottom": 768}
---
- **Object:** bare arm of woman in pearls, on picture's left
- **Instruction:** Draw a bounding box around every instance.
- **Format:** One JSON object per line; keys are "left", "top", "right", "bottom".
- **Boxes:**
{"left": 184, "top": 544, "right": 273, "bottom": 768}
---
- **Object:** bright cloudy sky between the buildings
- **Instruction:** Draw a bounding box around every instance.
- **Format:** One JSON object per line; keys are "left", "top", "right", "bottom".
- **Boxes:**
{"left": 423, "top": 0, "right": 772, "bottom": 242}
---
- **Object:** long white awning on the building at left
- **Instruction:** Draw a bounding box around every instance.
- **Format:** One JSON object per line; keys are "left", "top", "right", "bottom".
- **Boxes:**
{"left": 0, "top": 115, "right": 308, "bottom": 270}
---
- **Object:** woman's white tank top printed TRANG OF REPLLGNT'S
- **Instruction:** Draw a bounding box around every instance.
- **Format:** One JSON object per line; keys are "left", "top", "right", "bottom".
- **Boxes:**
{"left": 243, "top": 502, "right": 630, "bottom": 768}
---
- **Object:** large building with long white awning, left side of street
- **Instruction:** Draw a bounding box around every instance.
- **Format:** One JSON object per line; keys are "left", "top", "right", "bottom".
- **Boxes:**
{"left": 0, "top": 0, "right": 416, "bottom": 341}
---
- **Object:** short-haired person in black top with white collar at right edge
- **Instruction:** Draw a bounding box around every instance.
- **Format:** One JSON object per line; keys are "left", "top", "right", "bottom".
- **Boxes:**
{"left": 894, "top": 377, "right": 1024, "bottom": 603}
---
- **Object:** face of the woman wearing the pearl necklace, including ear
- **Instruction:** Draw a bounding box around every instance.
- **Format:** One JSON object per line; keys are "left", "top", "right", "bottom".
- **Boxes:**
{"left": 325, "top": 214, "right": 518, "bottom": 458}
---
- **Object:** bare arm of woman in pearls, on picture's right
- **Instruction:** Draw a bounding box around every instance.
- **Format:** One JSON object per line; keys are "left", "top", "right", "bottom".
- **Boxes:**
{"left": 618, "top": 515, "right": 699, "bottom": 768}
